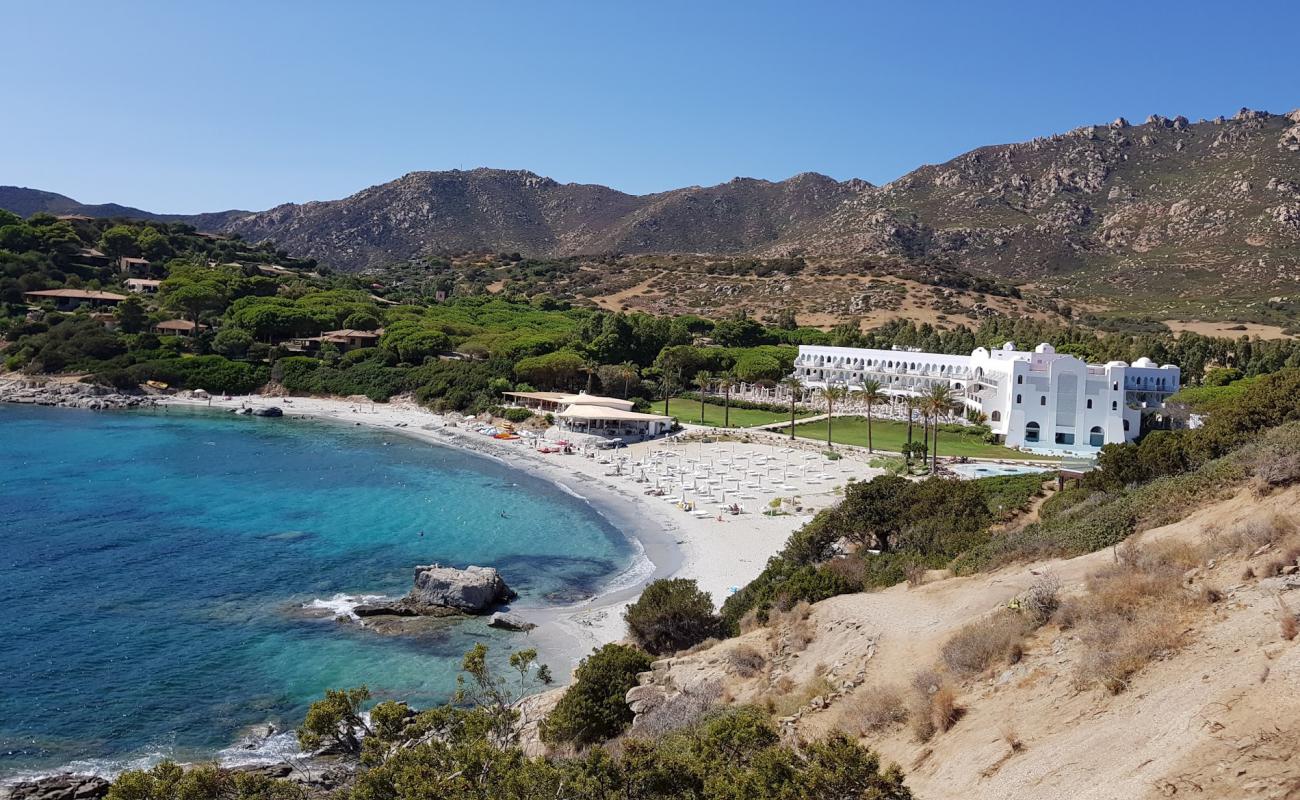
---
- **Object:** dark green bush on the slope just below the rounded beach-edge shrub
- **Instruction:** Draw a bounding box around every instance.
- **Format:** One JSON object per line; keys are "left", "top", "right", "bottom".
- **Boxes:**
{"left": 541, "top": 644, "right": 653, "bottom": 745}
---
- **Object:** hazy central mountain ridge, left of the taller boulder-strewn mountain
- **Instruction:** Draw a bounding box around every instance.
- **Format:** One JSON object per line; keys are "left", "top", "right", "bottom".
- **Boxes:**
{"left": 226, "top": 169, "right": 870, "bottom": 269}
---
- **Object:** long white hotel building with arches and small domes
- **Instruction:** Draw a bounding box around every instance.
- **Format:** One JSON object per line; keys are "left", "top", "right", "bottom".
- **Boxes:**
{"left": 794, "top": 342, "right": 1179, "bottom": 451}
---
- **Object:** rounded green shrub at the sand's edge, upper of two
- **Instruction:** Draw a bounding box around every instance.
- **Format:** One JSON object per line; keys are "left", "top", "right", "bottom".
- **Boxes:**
{"left": 623, "top": 578, "right": 719, "bottom": 656}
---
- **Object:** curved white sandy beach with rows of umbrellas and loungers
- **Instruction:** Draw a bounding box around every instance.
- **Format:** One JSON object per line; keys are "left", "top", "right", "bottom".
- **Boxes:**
{"left": 152, "top": 395, "right": 881, "bottom": 674}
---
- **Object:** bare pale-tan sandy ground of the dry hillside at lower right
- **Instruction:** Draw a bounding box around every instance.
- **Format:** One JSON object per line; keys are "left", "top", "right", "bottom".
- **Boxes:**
{"left": 644, "top": 488, "right": 1300, "bottom": 800}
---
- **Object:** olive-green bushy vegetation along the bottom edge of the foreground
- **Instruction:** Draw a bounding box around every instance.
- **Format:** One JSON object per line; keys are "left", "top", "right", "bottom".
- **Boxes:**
{"left": 109, "top": 645, "right": 911, "bottom": 800}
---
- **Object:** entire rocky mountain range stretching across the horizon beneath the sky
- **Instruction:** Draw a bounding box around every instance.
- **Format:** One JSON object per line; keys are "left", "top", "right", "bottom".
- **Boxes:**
{"left": 0, "top": 109, "right": 1300, "bottom": 298}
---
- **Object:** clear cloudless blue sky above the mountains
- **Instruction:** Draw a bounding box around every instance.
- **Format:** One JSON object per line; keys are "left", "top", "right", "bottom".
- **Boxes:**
{"left": 0, "top": 0, "right": 1300, "bottom": 212}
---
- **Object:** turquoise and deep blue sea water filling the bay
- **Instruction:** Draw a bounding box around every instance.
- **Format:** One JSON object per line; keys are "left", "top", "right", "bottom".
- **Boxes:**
{"left": 0, "top": 406, "right": 633, "bottom": 778}
